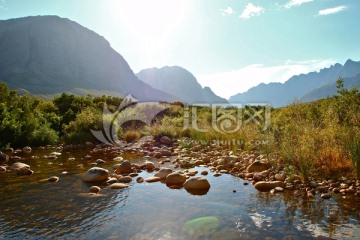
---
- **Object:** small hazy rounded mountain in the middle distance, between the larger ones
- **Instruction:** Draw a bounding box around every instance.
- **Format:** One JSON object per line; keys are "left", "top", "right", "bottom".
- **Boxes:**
{"left": 137, "top": 66, "right": 228, "bottom": 103}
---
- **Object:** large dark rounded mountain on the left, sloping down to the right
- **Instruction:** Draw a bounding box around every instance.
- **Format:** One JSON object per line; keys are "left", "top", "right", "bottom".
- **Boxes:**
{"left": 0, "top": 16, "right": 177, "bottom": 101}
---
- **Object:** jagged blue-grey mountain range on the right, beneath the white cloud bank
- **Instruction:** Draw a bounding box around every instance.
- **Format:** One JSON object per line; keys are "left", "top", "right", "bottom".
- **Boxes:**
{"left": 229, "top": 60, "right": 360, "bottom": 107}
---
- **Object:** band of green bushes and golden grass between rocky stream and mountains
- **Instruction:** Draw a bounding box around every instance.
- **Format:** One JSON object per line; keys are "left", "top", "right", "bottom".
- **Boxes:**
{"left": 0, "top": 78, "right": 360, "bottom": 181}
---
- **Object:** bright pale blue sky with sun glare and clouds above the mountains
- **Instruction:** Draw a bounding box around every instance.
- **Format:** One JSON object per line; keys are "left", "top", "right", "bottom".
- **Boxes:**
{"left": 0, "top": 0, "right": 360, "bottom": 98}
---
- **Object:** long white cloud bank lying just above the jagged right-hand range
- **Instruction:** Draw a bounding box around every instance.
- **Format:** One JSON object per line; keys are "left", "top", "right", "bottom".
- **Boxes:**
{"left": 196, "top": 59, "right": 335, "bottom": 99}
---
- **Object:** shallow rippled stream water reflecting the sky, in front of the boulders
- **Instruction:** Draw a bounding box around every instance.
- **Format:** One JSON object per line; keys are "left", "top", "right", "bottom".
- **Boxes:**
{"left": 0, "top": 151, "right": 360, "bottom": 239}
